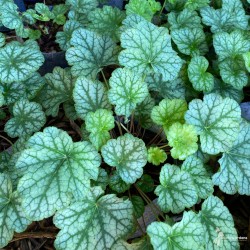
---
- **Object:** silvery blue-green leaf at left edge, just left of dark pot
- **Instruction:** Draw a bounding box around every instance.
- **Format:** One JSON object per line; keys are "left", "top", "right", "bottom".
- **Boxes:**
{"left": 0, "top": 40, "right": 44, "bottom": 83}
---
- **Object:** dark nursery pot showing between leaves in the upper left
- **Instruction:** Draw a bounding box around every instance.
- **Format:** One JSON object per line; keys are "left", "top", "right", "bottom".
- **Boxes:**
{"left": 38, "top": 51, "right": 69, "bottom": 76}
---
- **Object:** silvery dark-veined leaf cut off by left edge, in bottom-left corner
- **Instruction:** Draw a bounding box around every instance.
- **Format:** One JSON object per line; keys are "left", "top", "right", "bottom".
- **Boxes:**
{"left": 0, "top": 173, "right": 31, "bottom": 248}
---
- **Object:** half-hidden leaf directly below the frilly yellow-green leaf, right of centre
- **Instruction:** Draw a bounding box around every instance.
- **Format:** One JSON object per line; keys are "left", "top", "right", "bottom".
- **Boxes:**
{"left": 181, "top": 155, "right": 214, "bottom": 199}
